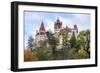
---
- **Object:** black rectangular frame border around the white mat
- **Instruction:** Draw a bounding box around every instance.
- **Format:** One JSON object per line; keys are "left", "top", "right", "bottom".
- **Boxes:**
{"left": 11, "top": 1, "right": 98, "bottom": 72}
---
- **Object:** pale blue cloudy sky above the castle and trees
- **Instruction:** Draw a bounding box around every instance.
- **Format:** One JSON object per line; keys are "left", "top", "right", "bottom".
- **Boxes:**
{"left": 24, "top": 11, "right": 91, "bottom": 47}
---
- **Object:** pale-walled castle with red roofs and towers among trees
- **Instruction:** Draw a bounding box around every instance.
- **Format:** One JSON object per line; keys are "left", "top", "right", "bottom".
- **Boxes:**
{"left": 35, "top": 18, "right": 78, "bottom": 48}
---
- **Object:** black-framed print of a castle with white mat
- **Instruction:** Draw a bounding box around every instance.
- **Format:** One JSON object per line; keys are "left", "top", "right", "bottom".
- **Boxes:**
{"left": 11, "top": 2, "right": 97, "bottom": 71}
